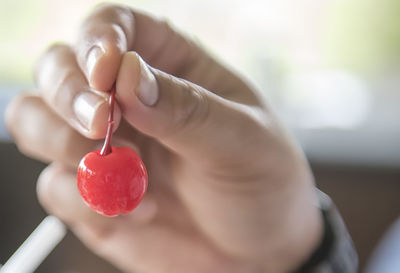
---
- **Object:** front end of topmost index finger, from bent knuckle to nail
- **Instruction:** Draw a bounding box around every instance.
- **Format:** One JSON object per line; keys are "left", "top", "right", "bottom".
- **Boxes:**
{"left": 76, "top": 5, "right": 134, "bottom": 91}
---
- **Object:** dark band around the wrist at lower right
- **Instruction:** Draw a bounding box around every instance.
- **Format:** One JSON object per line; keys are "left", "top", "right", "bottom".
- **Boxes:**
{"left": 295, "top": 190, "right": 358, "bottom": 273}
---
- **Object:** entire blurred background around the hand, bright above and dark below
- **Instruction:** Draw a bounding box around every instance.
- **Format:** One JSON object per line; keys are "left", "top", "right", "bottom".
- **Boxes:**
{"left": 0, "top": 0, "right": 400, "bottom": 273}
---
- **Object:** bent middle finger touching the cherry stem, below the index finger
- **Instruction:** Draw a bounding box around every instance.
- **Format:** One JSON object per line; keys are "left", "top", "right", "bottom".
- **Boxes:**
{"left": 35, "top": 45, "right": 121, "bottom": 139}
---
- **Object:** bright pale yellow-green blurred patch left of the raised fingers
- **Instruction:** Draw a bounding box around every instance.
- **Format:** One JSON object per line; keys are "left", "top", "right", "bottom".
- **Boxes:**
{"left": 0, "top": 0, "right": 138, "bottom": 85}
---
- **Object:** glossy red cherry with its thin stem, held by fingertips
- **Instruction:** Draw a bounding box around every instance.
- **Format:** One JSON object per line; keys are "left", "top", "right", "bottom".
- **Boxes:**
{"left": 77, "top": 85, "right": 147, "bottom": 216}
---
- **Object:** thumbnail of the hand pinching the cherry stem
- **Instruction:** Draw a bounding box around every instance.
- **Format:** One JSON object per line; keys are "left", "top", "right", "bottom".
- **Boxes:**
{"left": 137, "top": 57, "right": 158, "bottom": 106}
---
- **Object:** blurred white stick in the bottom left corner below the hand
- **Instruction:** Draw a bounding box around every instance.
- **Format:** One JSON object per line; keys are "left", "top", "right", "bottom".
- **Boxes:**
{"left": 0, "top": 216, "right": 67, "bottom": 273}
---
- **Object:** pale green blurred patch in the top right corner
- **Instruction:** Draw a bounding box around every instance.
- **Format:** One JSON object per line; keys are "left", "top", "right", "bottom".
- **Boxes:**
{"left": 323, "top": 0, "right": 400, "bottom": 72}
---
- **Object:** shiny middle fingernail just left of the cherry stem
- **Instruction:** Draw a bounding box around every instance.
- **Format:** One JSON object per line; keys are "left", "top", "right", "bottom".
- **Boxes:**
{"left": 73, "top": 92, "right": 106, "bottom": 130}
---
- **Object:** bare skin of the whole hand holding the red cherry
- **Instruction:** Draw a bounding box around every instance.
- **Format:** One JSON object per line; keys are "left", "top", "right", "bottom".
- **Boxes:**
{"left": 6, "top": 5, "right": 322, "bottom": 273}
